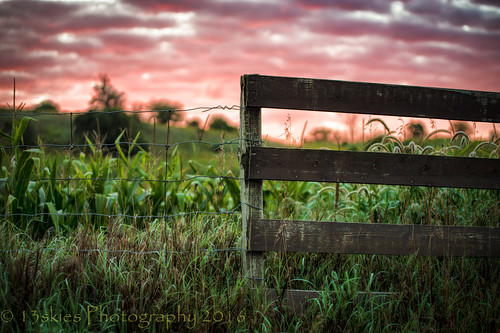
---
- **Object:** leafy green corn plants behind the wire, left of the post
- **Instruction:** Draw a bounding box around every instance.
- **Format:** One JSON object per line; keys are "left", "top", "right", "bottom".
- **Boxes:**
{"left": 0, "top": 124, "right": 240, "bottom": 238}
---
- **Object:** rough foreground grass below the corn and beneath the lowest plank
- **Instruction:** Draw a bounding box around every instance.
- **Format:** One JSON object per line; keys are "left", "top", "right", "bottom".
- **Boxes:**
{"left": 0, "top": 216, "right": 500, "bottom": 331}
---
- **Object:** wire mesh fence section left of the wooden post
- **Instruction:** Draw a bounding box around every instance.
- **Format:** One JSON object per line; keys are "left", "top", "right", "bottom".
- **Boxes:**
{"left": 0, "top": 105, "right": 261, "bottom": 254}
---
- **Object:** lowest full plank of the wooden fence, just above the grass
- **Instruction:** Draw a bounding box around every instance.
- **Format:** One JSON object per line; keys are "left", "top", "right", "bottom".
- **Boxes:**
{"left": 249, "top": 219, "right": 500, "bottom": 257}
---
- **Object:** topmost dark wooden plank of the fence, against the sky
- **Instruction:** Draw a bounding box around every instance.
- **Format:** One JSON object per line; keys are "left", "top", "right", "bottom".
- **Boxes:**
{"left": 243, "top": 74, "right": 500, "bottom": 122}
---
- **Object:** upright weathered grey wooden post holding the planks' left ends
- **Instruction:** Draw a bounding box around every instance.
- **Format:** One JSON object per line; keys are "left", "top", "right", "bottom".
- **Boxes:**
{"left": 239, "top": 75, "right": 264, "bottom": 286}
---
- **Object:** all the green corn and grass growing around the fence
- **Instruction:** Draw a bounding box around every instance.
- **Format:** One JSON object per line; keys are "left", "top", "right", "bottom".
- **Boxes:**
{"left": 0, "top": 117, "right": 500, "bottom": 332}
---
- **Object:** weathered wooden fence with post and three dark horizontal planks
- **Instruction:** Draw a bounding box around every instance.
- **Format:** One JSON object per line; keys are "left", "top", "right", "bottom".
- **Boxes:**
{"left": 240, "top": 74, "right": 500, "bottom": 306}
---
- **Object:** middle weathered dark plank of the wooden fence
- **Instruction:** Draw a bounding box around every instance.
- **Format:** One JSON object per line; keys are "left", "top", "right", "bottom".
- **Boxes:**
{"left": 246, "top": 147, "right": 500, "bottom": 189}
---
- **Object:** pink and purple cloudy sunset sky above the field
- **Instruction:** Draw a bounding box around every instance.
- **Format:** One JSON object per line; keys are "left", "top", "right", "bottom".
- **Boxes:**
{"left": 0, "top": 0, "right": 500, "bottom": 139}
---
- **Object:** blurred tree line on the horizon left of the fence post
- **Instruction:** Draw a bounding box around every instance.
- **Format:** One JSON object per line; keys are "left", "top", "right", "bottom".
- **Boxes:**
{"left": 0, "top": 74, "right": 237, "bottom": 151}
